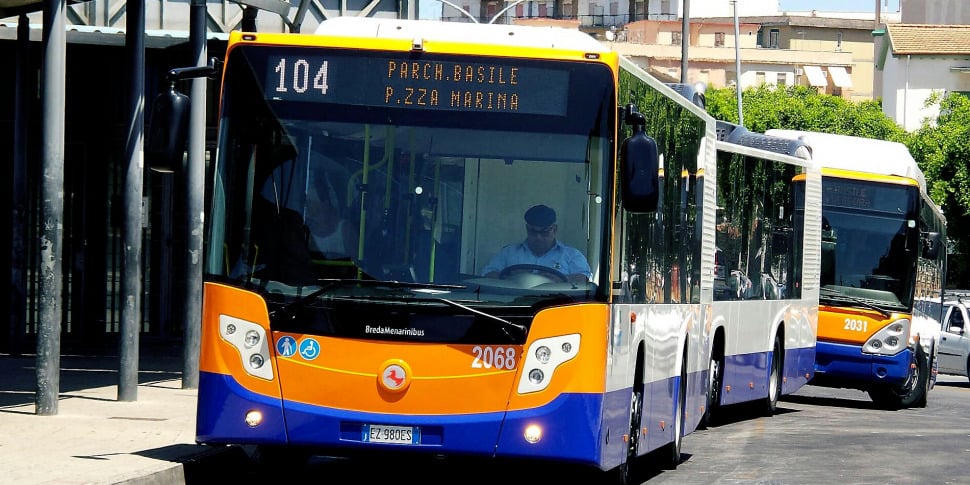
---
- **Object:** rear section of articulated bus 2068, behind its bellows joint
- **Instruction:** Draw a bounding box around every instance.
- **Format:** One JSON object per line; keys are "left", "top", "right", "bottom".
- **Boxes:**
{"left": 708, "top": 121, "right": 821, "bottom": 420}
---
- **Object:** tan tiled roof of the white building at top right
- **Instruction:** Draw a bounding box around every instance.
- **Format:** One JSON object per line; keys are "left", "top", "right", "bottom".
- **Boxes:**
{"left": 886, "top": 24, "right": 970, "bottom": 55}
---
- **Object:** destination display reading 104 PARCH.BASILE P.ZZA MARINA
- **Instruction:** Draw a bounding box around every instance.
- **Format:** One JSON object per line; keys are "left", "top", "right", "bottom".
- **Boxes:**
{"left": 264, "top": 51, "right": 569, "bottom": 116}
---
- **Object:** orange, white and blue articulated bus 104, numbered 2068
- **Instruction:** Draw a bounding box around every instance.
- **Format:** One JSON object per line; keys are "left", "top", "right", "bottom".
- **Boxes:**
{"left": 151, "top": 18, "right": 819, "bottom": 482}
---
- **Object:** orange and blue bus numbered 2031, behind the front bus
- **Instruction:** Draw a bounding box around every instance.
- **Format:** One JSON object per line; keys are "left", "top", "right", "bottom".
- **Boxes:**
{"left": 766, "top": 130, "right": 946, "bottom": 409}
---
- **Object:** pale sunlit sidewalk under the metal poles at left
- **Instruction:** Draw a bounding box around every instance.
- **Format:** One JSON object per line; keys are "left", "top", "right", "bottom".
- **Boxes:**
{"left": 0, "top": 346, "right": 242, "bottom": 485}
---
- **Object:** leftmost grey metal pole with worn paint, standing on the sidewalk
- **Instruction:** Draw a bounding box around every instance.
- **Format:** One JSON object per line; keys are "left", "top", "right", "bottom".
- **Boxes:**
{"left": 36, "top": 0, "right": 67, "bottom": 416}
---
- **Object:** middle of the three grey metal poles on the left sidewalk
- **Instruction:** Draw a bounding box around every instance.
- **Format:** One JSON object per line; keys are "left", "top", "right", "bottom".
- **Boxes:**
{"left": 118, "top": 0, "right": 145, "bottom": 401}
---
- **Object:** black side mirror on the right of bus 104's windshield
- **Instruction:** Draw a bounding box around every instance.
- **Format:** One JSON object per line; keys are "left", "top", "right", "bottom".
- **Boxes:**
{"left": 620, "top": 105, "right": 660, "bottom": 212}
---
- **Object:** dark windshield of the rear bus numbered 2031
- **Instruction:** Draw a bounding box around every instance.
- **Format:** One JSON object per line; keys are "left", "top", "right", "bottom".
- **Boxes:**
{"left": 821, "top": 177, "right": 919, "bottom": 309}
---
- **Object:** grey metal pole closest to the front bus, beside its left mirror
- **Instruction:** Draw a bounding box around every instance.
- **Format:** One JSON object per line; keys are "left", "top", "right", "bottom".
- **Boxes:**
{"left": 182, "top": 0, "right": 207, "bottom": 389}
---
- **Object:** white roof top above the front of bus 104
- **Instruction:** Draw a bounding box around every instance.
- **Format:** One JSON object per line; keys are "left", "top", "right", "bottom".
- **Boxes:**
{"left": 314, "top": 17, "right": 609, "bottom": 52}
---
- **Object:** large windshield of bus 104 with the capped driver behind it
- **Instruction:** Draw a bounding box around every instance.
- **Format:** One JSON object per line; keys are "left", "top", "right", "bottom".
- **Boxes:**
{"left": 205, "top": 45, "right": 616, "bottom": 304}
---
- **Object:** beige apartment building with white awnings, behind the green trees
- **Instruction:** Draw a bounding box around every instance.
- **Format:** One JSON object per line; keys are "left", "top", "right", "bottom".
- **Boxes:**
{"left": 613, "top": 16, "right": 873, "bottom": 101}
